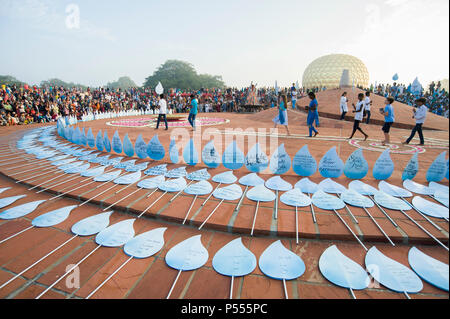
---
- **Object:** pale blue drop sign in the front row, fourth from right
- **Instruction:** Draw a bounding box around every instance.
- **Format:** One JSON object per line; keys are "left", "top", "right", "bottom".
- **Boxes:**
{"left": 259, "top": 240, "right": 306, "bottom": 280}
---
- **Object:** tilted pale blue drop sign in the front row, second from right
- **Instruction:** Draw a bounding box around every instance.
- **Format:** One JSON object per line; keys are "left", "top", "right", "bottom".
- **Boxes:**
{"left": 365, "top": 247, "right": 423, "bottom": 293}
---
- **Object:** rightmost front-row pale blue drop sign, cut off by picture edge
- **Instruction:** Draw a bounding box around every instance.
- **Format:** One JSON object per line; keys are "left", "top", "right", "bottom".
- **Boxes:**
{"left": 408, "top": 247, "right": 449, "bottom": 291}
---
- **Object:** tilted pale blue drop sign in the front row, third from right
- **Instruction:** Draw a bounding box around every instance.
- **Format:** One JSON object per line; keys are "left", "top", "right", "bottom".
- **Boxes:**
{"left": 319, "top": 245, "right": 370, "bottom": 290}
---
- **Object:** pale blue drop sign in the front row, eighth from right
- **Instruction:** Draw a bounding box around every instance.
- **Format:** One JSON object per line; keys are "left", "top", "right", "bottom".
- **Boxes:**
{"left": 95, "top": 218, "right": 136, "bottom": 247}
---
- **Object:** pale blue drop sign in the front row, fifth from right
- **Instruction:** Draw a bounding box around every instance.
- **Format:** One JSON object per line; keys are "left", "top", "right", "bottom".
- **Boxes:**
{"left": 212, "top": 238, "right": 256, "bottom": 277}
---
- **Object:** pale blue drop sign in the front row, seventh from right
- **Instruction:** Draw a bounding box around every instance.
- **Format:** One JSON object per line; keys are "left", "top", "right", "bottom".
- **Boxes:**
{"left": 123, "top": 227, "right": 167, "bottom": 259}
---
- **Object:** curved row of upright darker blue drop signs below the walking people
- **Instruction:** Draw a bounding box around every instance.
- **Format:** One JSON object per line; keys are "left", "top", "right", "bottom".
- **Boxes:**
{"left": 54, "top": 122, "right": 449, "bottom": 182}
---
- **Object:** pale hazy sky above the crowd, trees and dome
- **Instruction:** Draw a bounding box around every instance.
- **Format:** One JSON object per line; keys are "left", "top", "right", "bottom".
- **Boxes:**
{"left": 0, "top": 0, "right": 449, "bottom": 87}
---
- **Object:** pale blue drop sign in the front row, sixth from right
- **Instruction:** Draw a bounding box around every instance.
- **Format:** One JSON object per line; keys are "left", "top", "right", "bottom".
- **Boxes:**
{"left": 165, "top": 235, "right": 209, "bottom": 271}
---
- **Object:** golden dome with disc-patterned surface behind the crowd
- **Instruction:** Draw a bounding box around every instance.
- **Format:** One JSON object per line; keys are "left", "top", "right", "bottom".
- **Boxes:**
{"left": 302, "top": 54, "right": 369, "bottom": 89}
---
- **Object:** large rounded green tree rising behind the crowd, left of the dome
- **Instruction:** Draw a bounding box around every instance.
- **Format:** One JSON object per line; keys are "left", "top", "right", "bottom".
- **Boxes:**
{"left": 144, "top": 60, "right": 225, "bottom": 90}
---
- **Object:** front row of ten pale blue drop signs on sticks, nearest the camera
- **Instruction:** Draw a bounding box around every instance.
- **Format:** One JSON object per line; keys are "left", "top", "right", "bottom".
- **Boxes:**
{"left": 0, "top": 195, "right": 448, "bottom": 298}
